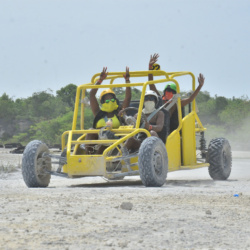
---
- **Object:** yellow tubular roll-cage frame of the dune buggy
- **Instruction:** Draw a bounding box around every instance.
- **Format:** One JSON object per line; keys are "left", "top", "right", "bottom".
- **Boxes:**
{"left": 61, "top": 70, "right": 205, "bottom": 176}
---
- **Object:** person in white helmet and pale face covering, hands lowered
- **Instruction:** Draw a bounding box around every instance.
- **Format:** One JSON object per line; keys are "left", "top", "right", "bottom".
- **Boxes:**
{"left": 124, "top": 90, "right": 166, "bottom": 151}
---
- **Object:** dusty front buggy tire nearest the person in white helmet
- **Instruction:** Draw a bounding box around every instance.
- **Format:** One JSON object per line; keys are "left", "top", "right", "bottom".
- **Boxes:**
{"left": 138, "top": 136, "right": 168, "bottom": 187}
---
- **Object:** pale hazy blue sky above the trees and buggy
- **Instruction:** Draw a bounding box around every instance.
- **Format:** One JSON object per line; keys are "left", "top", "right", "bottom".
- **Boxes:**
{"left": 0, "top": 0, "right": 250, "bottom": 99}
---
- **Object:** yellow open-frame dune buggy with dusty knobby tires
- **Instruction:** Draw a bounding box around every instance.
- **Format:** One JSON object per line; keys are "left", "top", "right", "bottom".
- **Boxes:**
{"left": 22, "top": 70, "right": 232, "bottom": 187}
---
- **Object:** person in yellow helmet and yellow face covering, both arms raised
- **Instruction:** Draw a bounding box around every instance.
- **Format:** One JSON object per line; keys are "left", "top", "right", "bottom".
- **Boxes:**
{"left": 86, "top": 67, "right": 131, "bottom": 154}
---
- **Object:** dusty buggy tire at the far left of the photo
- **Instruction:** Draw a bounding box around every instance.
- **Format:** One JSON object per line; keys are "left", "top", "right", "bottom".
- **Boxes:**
{"left": 22, "top": 140, "right": 51, "bottom": 187}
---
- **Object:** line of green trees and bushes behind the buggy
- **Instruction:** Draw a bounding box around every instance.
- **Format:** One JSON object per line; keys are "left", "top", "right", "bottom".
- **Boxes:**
{"left": 0, "top": 84, "right": 250, "bottom": 150}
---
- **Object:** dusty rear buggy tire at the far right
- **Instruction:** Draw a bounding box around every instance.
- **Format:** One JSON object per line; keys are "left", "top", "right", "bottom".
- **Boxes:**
{"left": 207, "top": 138, "right": 232, "bottom": 180}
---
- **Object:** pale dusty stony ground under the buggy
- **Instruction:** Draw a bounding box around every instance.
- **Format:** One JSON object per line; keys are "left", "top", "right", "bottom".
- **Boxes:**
{"left": 0, "top": 150, "right": 250, "bottom": 249}
